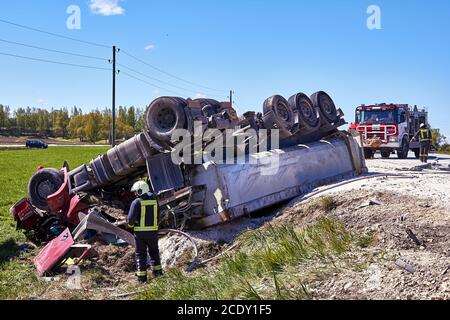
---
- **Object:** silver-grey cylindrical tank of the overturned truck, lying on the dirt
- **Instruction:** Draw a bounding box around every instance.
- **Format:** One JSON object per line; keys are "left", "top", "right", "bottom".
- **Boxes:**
{"left": 191, "top": 132, "right": 367, "bottom": 228}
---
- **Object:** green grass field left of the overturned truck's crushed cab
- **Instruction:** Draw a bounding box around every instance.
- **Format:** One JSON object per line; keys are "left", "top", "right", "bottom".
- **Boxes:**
{"left": 0, "top": 147, "right": 108, "bottom": 299}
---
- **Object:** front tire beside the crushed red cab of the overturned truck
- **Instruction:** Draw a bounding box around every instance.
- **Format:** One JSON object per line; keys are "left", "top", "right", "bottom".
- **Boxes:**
{"left": 28, "top": 169, "right": 64, "bottom": 211}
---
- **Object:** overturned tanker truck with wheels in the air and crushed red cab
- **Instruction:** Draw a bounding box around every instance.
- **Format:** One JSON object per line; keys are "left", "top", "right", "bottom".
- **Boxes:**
{"left": 11, "top": 91, "right": 367, "bottom": 241}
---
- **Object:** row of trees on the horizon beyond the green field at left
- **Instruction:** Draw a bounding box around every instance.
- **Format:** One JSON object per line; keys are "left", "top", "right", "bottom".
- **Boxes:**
{"left": 0, "top": 104, "right": 144, "bottom": 143}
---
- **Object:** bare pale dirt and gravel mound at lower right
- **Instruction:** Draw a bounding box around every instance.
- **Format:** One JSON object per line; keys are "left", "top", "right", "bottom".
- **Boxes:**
{"left": 277, "top": 190, "right": 450, "bottom": 299}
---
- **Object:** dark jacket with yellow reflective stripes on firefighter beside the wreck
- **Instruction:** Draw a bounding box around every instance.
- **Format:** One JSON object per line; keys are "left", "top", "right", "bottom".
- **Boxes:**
{"left": 128, "top": 193, "right": 159, "bottom": 233}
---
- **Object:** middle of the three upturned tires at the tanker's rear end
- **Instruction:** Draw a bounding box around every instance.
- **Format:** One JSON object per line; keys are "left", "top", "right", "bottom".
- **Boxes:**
{"left": 289, "top": 92, "right": 320, "bottom": 129}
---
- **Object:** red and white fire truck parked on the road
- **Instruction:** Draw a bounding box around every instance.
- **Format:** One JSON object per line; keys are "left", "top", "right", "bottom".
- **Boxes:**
{"left": 350, "top": 103, "right": 428, "bottom": 159}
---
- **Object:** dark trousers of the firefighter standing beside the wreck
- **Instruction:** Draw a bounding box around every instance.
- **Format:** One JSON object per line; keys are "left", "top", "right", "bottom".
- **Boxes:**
{"left": 135, "top": 231, "right": 162, "bottom": 281}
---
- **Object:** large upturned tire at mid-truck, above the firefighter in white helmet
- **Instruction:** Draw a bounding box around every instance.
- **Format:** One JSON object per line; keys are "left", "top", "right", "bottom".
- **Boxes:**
{"left": 145, "top": 97, "right": 187, "bottom": 142}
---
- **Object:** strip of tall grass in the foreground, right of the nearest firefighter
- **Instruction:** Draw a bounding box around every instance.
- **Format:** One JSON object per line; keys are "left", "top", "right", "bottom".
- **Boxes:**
{"left": 138, "top": 218, "right": 368, "bottom": 300}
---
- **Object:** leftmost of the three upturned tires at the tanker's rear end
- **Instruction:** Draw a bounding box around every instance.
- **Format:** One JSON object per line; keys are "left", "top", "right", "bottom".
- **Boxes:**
{"left": 263, "top": 95, "right": 295, "bottom": 131}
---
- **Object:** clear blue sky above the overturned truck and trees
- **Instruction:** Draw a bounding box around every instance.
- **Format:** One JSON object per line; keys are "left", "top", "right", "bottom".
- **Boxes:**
{"left": 0, "top": 0, "right": 450, "bottom": 137}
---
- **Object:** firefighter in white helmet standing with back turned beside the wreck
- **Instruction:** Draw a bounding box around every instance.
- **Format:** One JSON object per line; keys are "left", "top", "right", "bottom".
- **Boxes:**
{"left": 128, "top": 181, "right": 162, "bottom": 282}
